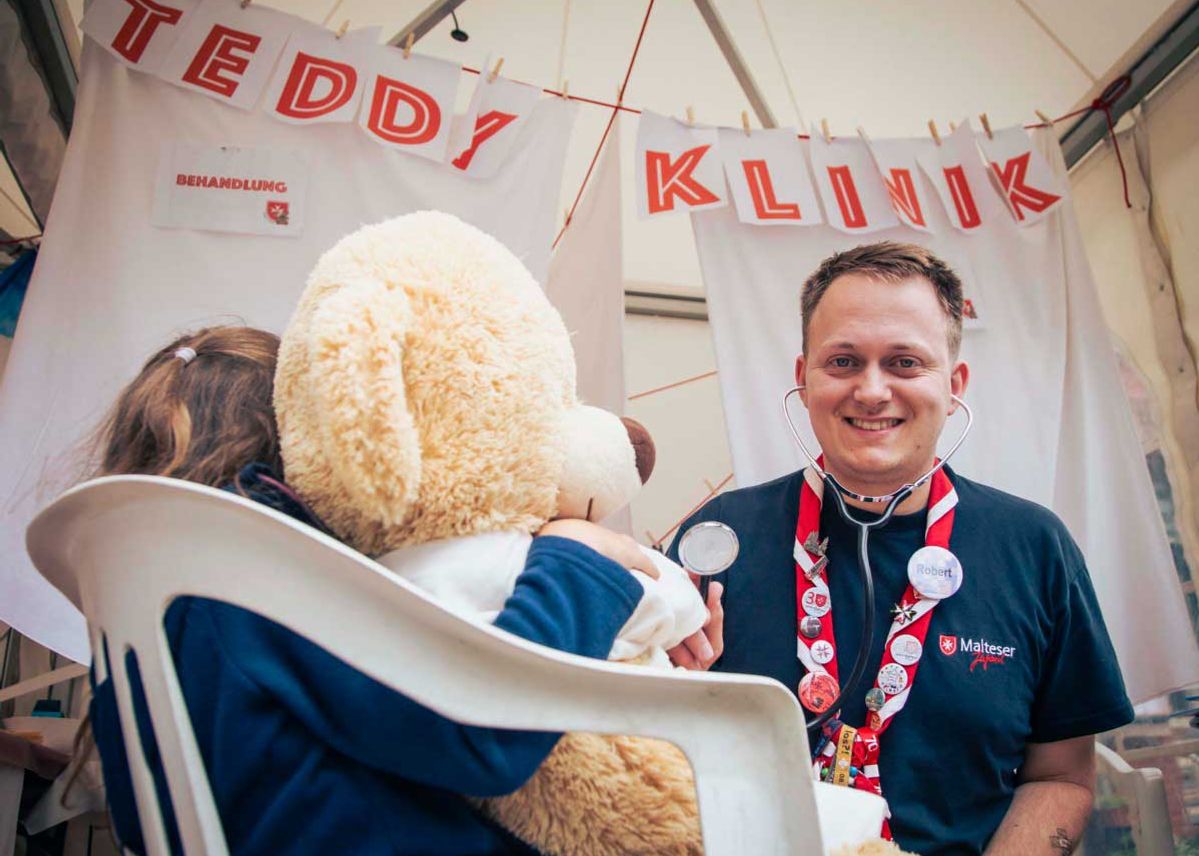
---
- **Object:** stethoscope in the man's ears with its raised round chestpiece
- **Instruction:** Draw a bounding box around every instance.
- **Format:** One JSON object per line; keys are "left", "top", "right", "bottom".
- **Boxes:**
{"left": 679, "top": 386, "right": 974, "bottom": 730}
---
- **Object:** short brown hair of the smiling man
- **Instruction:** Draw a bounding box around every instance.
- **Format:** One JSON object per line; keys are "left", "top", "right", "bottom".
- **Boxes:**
{"left": 800, "top": 241, "right": 964, "bottom": 360}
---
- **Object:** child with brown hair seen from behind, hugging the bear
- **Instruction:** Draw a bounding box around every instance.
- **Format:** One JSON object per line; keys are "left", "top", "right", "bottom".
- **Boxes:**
{"left": 82, "top": 327, "right": 656, "bottom": 855}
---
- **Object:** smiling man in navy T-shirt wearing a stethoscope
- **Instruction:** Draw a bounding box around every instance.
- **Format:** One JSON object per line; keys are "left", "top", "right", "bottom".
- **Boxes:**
{"left": 670, "top": 242, "right": 1133, "bottom": 856}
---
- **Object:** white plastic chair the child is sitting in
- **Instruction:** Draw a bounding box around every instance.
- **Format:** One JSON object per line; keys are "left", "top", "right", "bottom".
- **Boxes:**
{"left": 26, "top": 476, "right": 823, "bottom": 856}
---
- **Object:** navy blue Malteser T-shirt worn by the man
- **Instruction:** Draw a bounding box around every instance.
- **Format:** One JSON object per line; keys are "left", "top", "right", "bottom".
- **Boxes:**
{"left": 669, "top": 472, "right": 1133, "bottom": 854}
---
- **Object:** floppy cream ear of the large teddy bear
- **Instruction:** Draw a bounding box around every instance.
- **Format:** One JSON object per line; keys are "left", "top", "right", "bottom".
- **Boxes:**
{"left": 307, "top": 278, "right": 421, "bottom": 525}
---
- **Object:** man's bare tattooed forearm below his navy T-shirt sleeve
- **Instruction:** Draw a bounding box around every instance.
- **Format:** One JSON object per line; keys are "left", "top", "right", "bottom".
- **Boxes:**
{"left": 987, "top": 735, "right": 1095, "bottom": 856}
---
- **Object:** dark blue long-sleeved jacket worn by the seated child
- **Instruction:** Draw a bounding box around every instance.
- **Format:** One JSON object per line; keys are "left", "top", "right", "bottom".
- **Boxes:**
{"left": 92, "top": 467, "right": 641, "bottom": 855}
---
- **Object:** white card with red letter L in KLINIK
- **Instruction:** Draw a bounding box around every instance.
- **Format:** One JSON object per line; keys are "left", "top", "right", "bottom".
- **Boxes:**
{"left": 718, "top": 128, "right": 824, "bottom": 225}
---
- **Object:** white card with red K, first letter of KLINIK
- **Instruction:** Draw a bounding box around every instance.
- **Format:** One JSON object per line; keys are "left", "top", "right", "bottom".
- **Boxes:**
{"left": 633, "top": 110, "right": 728, "bottom": 219}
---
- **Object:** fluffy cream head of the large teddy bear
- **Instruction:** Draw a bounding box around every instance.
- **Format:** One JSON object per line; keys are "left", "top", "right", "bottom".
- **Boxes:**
{"left": 275, "top": 211, "right": 653, "bottom": 555}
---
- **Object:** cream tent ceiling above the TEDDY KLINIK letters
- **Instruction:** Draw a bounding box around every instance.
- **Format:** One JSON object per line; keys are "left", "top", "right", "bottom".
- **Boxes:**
{"left": 53, "top": 0, "right": 1191, "bottom": 287}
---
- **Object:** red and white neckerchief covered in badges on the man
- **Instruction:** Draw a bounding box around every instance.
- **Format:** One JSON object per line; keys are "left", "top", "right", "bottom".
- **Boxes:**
{"left": 794, "top": 459, "right": 962, "bottom": 837}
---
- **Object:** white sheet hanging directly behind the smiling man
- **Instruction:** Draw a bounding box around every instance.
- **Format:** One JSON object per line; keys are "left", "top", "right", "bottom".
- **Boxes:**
{"left": 692, "top": 128, "right": 1199, "bottom": 701}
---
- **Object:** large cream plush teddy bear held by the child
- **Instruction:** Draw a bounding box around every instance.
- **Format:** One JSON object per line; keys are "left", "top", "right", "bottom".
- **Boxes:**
{"left": 275, "top": 212, "right": 906, "bottom": 856}
